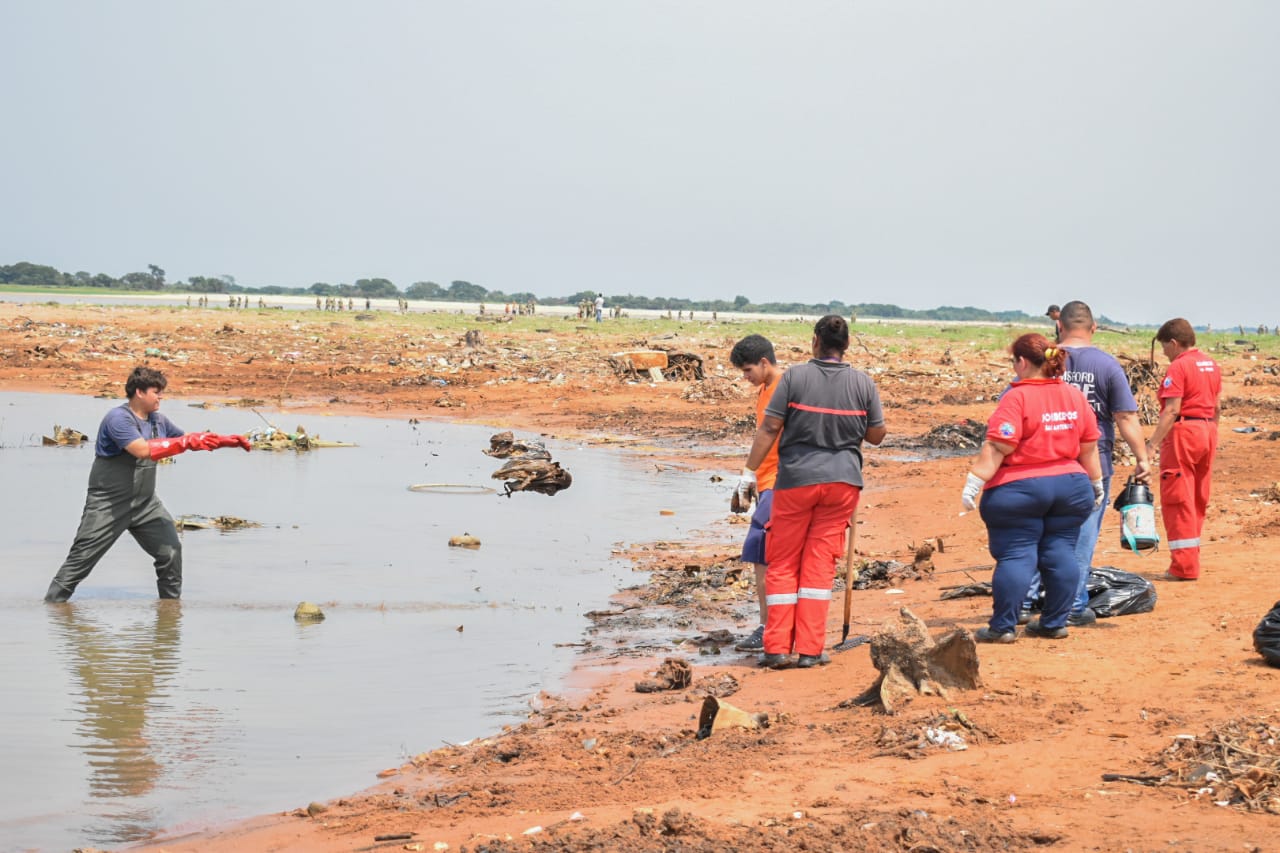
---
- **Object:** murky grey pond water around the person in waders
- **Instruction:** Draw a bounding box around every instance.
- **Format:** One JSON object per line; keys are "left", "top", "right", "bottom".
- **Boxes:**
{"left": 0, "top": 393, "right": 727, "bottom": 850}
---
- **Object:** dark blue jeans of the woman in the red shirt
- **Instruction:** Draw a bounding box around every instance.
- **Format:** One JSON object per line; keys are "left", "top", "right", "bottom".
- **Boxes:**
{"left": 978, "top": 474, "right": 1093, "bottom": 634}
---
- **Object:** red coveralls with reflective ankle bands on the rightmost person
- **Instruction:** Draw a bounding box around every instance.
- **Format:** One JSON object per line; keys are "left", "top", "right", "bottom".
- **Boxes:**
{"left": 1160, "top": 348, "right": 1222, "bottom": 580}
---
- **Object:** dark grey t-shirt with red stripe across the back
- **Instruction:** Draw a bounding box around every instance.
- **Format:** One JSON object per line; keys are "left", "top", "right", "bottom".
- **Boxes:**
{"left": 764, "top": 359, "right": 884, "bottom": 489}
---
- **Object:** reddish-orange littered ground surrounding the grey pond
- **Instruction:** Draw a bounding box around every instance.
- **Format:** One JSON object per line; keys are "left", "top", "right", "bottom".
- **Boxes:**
{"left": 0, "top": 304, "right": 1280, "bottom": 853}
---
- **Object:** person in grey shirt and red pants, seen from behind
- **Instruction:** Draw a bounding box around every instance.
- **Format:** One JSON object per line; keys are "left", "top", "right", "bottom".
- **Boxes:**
{"left": 739, "top": 314, "right": 886, "bottom": 669}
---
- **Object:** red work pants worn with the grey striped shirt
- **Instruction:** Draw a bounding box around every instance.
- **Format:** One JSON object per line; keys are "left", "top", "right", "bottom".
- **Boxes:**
{"left": 764, "top": 483, "right": 861, "bottom": 656}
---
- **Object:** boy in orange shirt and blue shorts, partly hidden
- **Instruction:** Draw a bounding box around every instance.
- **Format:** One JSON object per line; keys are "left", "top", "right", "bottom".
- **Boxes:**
{"left": 728, "top": 334, "right": 782, "bottom": 652}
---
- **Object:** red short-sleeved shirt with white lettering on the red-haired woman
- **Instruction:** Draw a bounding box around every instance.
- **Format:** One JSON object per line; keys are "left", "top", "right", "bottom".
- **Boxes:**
{"left": 987, "top": 379, "right": 1101, "bottom": 488}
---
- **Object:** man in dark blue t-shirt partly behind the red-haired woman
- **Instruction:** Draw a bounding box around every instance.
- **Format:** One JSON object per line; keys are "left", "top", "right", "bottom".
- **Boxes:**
{"left": 1018, "top": 301, "right": 1151, "bottom": 626}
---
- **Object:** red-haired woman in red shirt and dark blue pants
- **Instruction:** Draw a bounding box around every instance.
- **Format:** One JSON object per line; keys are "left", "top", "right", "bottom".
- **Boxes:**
{"left": 960, "top": 333, "right": 1102, "bottom": 643}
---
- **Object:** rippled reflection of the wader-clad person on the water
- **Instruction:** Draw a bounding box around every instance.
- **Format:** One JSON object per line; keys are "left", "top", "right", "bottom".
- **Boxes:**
{"left": 46, "top": 601, "right": 189, "bottom": 844}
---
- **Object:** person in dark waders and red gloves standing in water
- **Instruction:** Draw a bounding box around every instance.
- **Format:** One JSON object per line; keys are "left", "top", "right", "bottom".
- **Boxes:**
{"left": 45, "top": 368, "right": 250, "bottom": 602}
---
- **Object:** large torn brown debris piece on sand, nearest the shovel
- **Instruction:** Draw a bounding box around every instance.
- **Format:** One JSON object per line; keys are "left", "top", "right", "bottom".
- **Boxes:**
{"left": 851, "top": 607, "right": 982, "bottom": 713}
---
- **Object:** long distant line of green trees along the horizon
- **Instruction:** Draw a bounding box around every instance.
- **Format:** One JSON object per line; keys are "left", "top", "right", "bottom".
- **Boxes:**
{"left": 0, "top": 261, "right": 1049, "bottom": 323}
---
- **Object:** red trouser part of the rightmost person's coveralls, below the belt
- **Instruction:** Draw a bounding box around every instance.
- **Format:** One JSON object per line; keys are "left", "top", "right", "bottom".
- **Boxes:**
{"left": 1160, "top": 420, "right": 1217, "bottom": 579}
